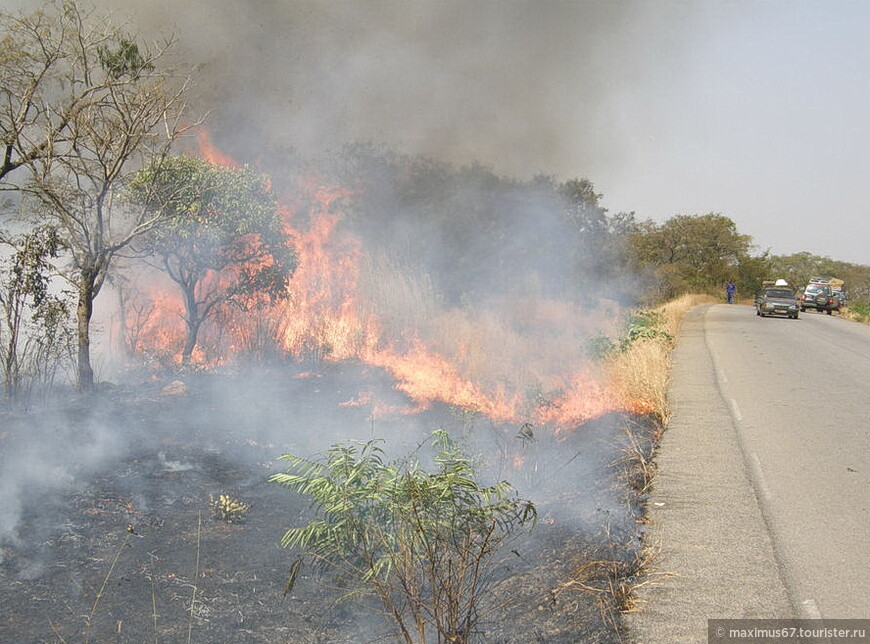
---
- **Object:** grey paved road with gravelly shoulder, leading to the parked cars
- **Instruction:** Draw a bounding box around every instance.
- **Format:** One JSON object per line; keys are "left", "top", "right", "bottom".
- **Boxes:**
{"left": 628, "top": 305, "right": 870, "bottom": 644}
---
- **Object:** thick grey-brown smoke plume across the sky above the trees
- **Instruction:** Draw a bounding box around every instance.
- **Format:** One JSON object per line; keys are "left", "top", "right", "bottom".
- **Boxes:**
{"left": 47, "top": 0, "right": 648, "bottom": 181}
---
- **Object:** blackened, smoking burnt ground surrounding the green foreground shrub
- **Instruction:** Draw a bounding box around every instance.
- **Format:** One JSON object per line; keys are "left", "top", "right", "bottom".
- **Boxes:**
{"left": 0, "top": 364, "right": 658, "bottom": 644}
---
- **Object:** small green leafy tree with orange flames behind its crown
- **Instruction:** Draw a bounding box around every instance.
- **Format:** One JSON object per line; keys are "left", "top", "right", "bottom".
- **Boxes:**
{"left": 128, "top": 157, "right": 296, "bottom": 365}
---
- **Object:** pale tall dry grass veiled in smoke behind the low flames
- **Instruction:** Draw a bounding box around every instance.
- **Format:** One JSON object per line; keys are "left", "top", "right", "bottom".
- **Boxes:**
{"left": 359, "top": 256, "right": 619, "bottom": 413}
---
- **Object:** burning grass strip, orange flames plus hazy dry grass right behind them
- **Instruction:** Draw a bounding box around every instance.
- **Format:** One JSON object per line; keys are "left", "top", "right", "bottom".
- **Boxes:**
{"left": 116, "top": 150, "right": 650, "bottom": 426}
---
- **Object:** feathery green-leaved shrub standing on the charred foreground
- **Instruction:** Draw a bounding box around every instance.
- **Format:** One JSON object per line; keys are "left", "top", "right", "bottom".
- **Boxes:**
{"left": 271, "top": 431, "right": 536, "bottom": 644}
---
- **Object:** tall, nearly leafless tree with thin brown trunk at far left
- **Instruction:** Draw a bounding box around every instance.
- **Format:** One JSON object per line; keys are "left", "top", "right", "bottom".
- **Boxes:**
{"left": 0, "top": 1, "right": 196, "bottom": 392}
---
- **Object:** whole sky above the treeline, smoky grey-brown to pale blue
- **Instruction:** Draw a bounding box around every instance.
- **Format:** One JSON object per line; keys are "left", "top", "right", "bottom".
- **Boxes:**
{"left": 7, "top": 0, "right": 870, "bottom": 265}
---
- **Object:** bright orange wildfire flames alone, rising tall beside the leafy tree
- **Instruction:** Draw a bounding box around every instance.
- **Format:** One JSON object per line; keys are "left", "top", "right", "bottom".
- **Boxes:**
{"left": 126, "top": 134, "right": 640, "bottom": 427}
